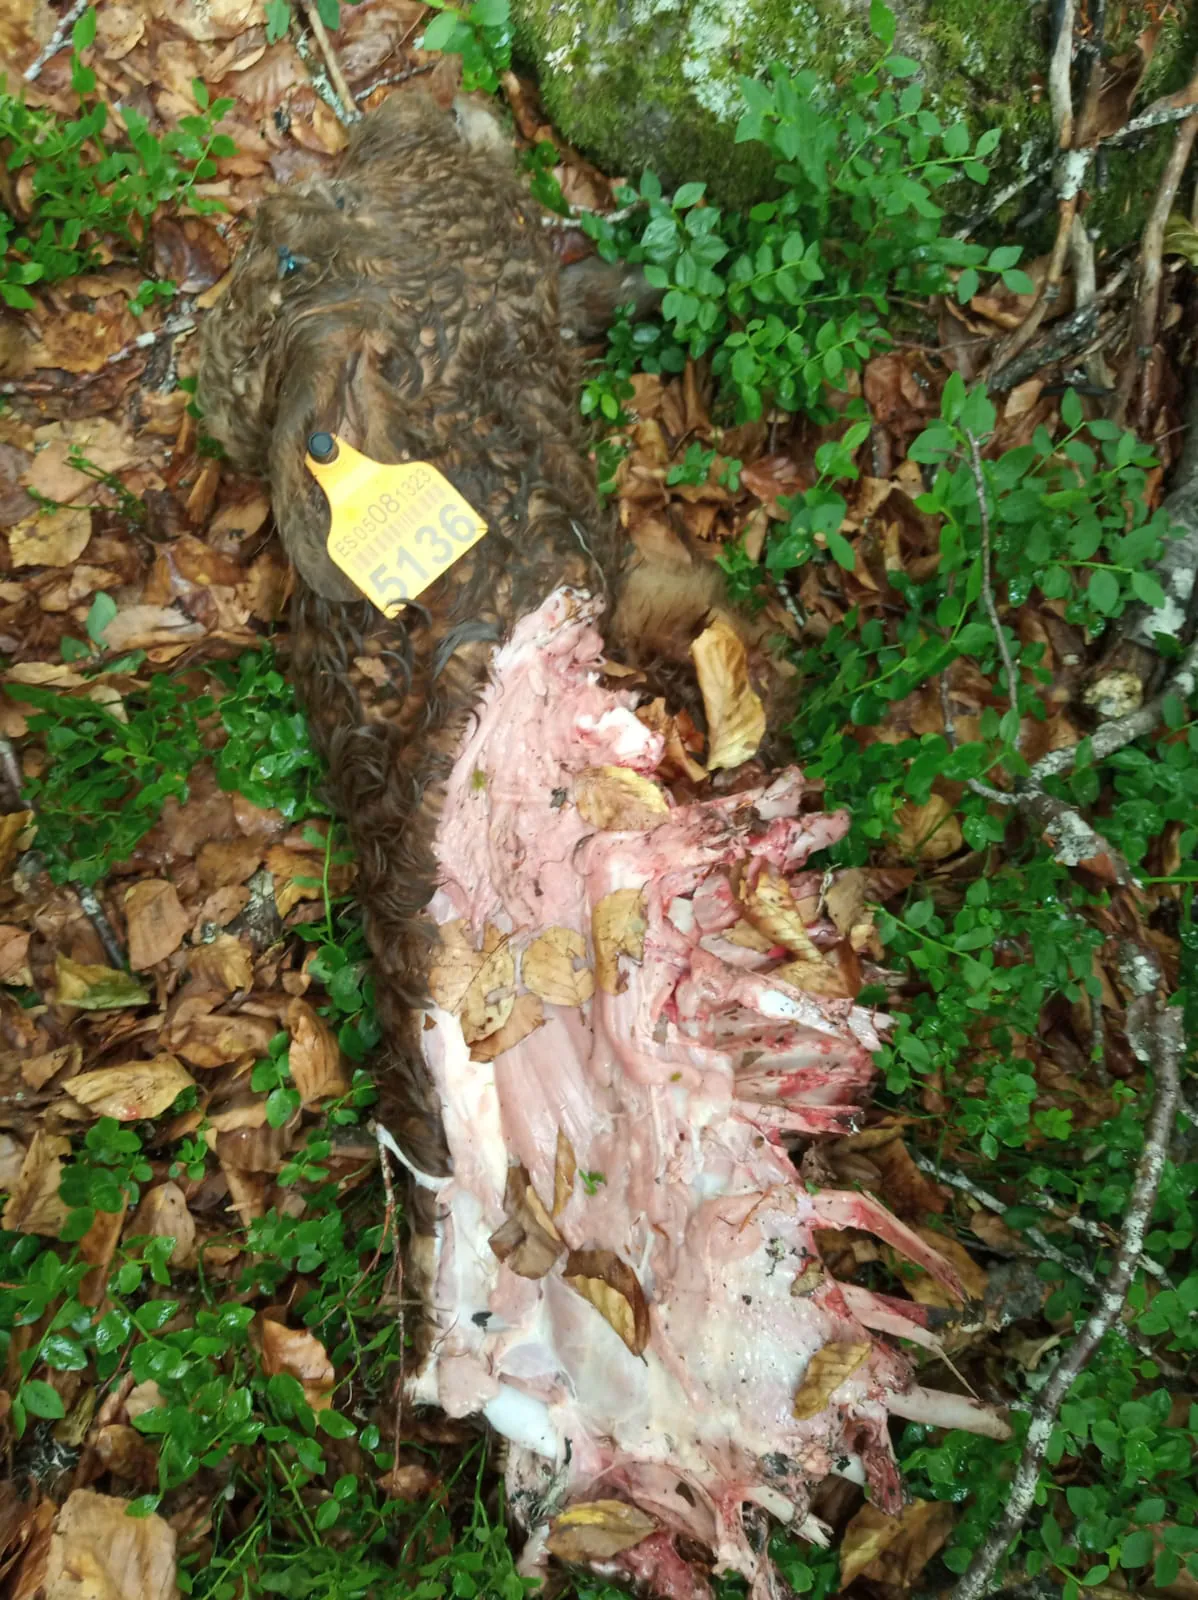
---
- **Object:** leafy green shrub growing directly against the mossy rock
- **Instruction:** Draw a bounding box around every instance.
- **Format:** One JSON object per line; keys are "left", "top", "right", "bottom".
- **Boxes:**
{"left": 582, "top": 0, "right": 1032, "bottom": 421}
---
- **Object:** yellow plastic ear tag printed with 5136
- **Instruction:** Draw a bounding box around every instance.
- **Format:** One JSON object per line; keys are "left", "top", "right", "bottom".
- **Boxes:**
{"left": 305, "top": 434, "right": 486, "bottom": 616}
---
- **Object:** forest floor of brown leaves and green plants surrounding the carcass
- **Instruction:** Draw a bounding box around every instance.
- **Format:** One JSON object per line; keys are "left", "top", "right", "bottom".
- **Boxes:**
{"left": 0, "top": 9, "right": 1198, "bottom": 1600}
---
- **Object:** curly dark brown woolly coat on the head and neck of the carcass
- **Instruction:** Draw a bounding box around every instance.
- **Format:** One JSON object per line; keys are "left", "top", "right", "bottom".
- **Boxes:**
{"left": 200, "top": 93, "right": 770, "bottom": 1174}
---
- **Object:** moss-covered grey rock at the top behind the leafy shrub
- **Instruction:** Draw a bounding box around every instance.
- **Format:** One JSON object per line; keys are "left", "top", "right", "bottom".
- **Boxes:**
{"left": 512, "top": 0, "right": 1198, "bottom": 241}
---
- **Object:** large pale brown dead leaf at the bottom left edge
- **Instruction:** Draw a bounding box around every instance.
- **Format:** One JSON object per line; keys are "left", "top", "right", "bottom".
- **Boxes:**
{"left": 45, "top": 1490, "right": 179, "bottom": 1600}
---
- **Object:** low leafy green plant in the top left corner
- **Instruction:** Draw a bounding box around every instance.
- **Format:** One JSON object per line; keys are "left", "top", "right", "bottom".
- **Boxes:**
{"left": 0, "top": 8, "right": 235, "bottom": 310}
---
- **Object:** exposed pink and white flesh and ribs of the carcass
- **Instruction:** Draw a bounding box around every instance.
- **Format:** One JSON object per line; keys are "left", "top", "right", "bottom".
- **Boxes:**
{"left": 409, "top": 590, "right": 1006, "bottom": 1600}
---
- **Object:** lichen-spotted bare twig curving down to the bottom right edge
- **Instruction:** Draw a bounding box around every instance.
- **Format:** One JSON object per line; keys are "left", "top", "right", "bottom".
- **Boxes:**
{"left": 950, "top": 972, "right": 1182, "bottom": 1600}
